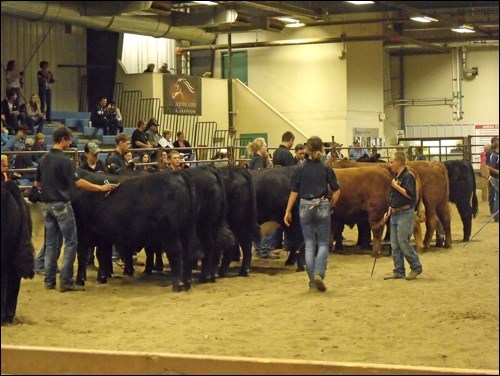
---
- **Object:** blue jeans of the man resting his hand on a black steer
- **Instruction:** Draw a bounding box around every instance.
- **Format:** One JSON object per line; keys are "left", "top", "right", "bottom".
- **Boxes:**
{"left": 42, "top": 201, "right": 77, "bottom": 286}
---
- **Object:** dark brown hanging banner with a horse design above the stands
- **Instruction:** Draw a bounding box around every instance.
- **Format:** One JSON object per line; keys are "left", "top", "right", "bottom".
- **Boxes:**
{"left": 163, "top": 74, "right": 201, "bottom": 115}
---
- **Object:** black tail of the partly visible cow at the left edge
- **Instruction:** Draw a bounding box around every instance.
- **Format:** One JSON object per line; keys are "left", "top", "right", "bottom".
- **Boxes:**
{"left": 3, "top": 182, "right": 35, "bottom": 278}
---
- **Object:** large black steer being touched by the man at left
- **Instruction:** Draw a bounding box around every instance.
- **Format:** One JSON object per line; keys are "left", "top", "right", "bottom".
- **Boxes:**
{"left": 72, "top": 171, "right": 200, "bottom": 291}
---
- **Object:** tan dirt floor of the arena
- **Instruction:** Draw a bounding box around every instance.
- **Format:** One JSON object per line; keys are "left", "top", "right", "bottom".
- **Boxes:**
{"left": 2, "top": 198, "right": 499, "bottom": 369}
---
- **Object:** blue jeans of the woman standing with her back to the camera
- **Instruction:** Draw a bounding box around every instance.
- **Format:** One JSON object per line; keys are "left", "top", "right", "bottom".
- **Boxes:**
{"left": 299, "top": 199, "right": 330, "bottom": 287}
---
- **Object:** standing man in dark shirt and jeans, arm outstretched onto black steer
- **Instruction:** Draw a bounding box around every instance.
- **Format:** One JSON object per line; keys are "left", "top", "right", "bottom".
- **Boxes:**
{"left": 35, "top": 127, "right": 116, "bottom": 292}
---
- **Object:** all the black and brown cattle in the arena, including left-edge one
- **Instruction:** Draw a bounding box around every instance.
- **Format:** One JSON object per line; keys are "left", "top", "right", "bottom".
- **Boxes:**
{"left": 2, "top": 161, "right": 478, "bottom": 324}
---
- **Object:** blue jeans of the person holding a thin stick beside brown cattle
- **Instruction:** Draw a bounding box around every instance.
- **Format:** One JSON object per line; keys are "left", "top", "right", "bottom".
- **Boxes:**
{"left": 391, "top": 208, "right": 422, "bottom": 278}
